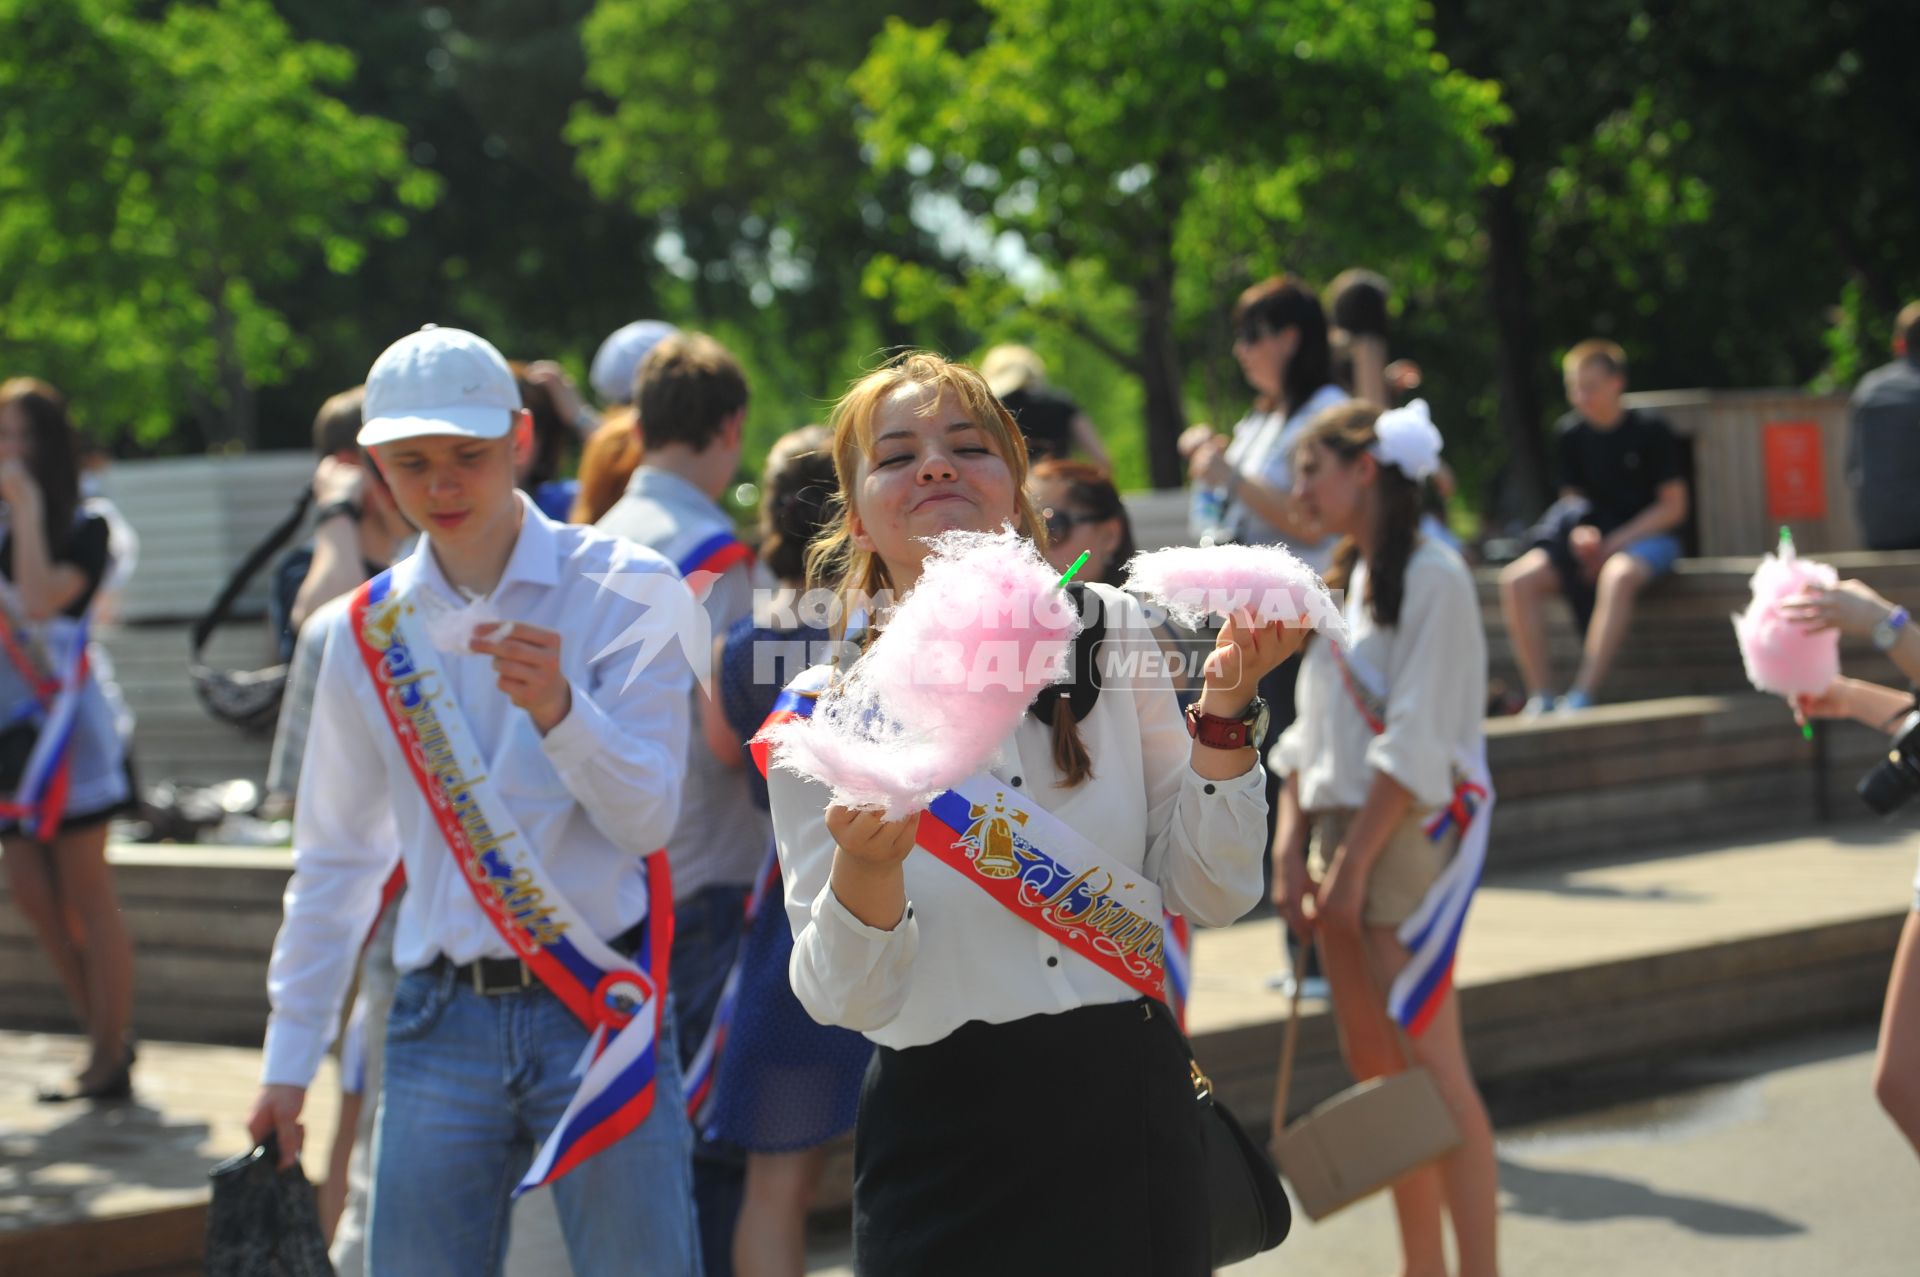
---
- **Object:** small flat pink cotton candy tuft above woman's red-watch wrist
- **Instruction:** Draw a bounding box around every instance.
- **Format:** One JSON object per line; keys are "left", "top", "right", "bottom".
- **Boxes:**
{"left": 1127, "top": 545, "right": 1348, "bottom": 641}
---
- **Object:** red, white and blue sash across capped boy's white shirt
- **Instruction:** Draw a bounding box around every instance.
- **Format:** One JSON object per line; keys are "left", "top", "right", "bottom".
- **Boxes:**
{"left": 349, "top": 570, "right": 674, "bottom": 1196}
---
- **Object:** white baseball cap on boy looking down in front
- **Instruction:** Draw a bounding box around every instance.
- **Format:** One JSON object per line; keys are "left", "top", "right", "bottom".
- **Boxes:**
{"left": 359, "top": 325, "right": 520, "bottom": 447}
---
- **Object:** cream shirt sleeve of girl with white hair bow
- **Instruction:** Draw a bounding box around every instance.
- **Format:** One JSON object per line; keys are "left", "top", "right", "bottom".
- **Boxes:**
{"left": 1367, "top": 570, "right": 1486, "bottom": 807}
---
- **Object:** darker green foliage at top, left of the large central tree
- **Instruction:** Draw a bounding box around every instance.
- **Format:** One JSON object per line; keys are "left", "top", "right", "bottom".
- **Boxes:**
{"left": 566, "top": 0, "right": 977, "bottom": 458}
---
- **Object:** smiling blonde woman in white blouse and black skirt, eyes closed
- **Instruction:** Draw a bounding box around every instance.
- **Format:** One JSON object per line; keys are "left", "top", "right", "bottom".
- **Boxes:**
{"left": 768, "top": 353, "right": 1302, "bottom": 1277}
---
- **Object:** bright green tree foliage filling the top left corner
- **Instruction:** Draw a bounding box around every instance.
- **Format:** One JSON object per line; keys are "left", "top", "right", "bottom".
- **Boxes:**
{"left": 0, "top": 0, "right": 438, "bottom": 444}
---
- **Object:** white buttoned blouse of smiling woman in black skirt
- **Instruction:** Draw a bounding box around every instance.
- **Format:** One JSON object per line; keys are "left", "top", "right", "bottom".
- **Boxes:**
{"left": 768, "top": 586, "right": 1267, "bottom": 1047}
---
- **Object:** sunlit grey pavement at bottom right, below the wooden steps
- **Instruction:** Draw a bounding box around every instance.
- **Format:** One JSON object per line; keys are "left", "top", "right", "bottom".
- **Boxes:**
{"left": 808, "top": 1029, "right": 1920, "bottom": 1277}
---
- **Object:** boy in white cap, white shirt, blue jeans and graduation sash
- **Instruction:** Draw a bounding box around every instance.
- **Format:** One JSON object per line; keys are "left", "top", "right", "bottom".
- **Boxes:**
{"left": 248, "top": 326, "right": 699, "bottom": 1277}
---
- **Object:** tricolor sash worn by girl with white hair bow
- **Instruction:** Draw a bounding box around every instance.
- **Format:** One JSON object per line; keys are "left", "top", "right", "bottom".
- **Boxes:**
{"left": 1325, "top": 639, "right": 1494, "bottom": 1037}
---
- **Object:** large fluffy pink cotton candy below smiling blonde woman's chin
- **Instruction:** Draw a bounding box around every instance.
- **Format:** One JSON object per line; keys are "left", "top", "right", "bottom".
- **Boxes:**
{"left": 768, "top": 528, "right": 1081, "bottom": 820}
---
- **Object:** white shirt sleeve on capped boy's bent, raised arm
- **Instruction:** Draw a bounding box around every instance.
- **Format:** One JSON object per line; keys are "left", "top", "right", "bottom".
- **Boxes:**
{"left": 541, "top": 563, "right": 697, "bottom": 855}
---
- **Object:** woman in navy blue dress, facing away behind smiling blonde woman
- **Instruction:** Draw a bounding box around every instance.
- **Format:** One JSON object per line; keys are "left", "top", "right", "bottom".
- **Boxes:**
{"left": 703, "top": 426, "right": 874, "bottom": 1277}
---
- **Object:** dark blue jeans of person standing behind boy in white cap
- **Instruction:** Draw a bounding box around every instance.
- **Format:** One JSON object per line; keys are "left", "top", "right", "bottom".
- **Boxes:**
{"left": 668, "top": 885, "right": 749, "bottom": 1277}
